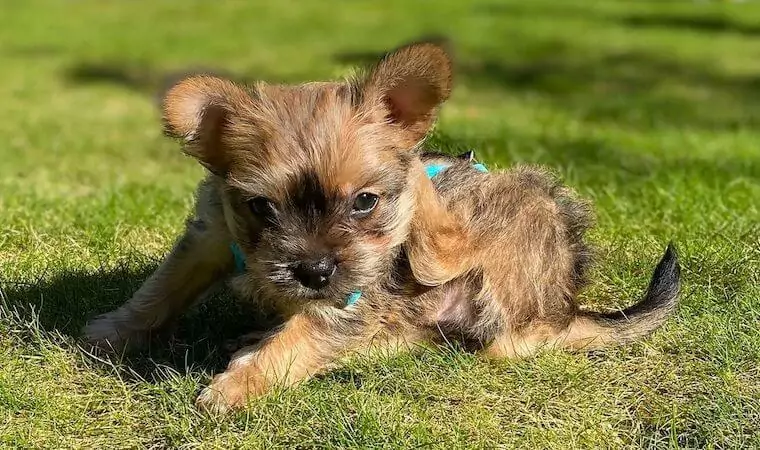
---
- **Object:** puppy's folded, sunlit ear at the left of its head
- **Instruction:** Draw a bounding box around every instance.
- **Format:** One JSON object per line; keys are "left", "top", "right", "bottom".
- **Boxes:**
{"left": 162, "top": 75, "right": 253, "bottom": 176}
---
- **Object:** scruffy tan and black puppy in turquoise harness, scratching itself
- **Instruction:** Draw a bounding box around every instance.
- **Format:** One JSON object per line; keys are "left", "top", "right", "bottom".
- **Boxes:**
{"left": 85, "top": 42, "right": 679, "bottom": 411}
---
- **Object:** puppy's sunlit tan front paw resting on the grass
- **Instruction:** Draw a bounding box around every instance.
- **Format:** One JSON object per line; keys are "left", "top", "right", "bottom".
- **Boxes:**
{"left": 195, "top": 372, "right": 267, "bottom": 414}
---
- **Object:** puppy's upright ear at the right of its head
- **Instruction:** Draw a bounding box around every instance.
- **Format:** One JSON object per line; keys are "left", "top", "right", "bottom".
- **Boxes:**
{"left": 361, "top": 42, "right": 452, "bottom": 147}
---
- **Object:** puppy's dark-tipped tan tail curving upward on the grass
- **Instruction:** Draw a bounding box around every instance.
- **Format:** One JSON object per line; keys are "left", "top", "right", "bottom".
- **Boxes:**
{"left": 561, "top": 243, "right": 681, "bottom": 350}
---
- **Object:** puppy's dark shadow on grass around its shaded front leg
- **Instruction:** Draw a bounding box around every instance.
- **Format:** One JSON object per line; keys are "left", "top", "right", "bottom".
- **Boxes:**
{"left": 0, "top": 265, "right": 274, "bottom": 380}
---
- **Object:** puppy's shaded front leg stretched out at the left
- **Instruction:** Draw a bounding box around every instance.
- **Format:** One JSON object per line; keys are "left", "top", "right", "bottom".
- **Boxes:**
{"left": 84, "top": 215, "right": 233, "bottom": 350}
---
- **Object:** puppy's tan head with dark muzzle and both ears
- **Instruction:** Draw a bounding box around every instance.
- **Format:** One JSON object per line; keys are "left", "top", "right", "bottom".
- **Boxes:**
{"left": 163, "top": 43, "right": 451, "bottom": 301}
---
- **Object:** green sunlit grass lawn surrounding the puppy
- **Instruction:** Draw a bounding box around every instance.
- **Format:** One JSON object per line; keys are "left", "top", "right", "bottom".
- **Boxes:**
{"left": 0, "top": 0, "right": 760, "bottom": 449}
